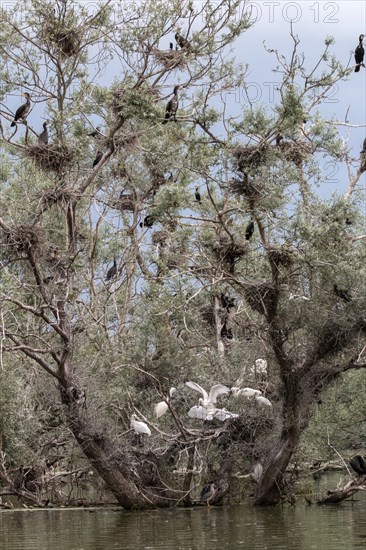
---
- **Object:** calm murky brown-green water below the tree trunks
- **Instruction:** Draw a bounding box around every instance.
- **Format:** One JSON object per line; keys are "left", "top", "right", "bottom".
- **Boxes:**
{"left": 0, "top": 492, "right": 366, "bottom": 550}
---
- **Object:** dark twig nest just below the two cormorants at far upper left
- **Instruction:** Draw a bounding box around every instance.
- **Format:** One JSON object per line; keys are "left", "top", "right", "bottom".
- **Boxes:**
{"left": 26, "top": 144, "right": 75, "bottom": 172}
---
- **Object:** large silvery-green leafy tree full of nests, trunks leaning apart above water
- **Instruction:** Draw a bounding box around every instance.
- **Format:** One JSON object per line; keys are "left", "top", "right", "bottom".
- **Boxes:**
{"left": 0, "top": 0, "right": 365, "bottom": 508}
